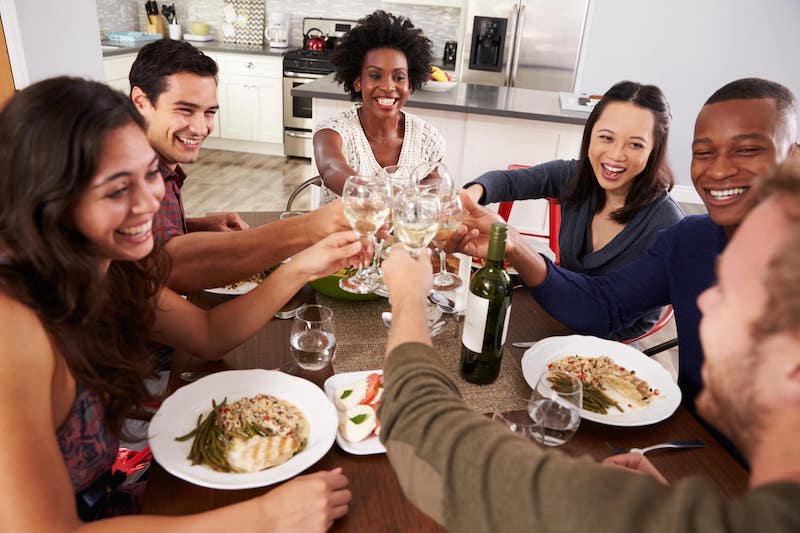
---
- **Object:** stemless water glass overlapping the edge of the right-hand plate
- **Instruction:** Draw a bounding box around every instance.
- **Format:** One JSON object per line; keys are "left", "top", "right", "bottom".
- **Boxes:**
{"left": 528, "top": 370, "right": 583, "bottom": 446}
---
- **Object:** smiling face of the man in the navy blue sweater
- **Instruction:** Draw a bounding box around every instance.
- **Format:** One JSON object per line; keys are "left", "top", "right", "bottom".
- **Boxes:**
{"left": 692, "top": 98, "right": 791, "bottom": 235}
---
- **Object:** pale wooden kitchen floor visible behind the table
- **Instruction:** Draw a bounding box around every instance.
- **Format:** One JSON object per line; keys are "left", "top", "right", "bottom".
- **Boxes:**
{"left": 183, "top": 149, "right": 705, "bottom": 375}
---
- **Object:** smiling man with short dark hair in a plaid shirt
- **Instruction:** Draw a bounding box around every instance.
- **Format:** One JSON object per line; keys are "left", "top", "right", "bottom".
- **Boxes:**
{"left": 129, "top": 39, "right": 349, "bottom": 291}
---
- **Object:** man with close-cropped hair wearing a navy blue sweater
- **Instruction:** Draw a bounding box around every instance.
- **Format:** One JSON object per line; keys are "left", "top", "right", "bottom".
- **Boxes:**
{"left": 450, "top": 78, "right": 797, "bottom": 409}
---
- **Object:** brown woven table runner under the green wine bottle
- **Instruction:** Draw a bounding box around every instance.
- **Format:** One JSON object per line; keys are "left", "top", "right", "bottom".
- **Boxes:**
{"left": 317, "top": 294, "right": 531, "bottom": 413}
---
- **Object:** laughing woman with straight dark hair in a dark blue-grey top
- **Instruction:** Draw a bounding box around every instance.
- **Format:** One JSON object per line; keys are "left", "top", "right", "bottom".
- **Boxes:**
{"left": 465, "top": 81, "right": 684, "bottom": 340}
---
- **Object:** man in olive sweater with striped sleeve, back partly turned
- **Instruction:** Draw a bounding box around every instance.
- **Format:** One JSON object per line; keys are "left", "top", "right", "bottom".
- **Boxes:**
{"left": 379, "top": 159, "right": 800, "bottom": 532}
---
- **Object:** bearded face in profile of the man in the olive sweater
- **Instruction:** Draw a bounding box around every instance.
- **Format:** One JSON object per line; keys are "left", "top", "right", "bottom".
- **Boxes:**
{"left": 697, "top": 198, "right": 788, "bottom": 451}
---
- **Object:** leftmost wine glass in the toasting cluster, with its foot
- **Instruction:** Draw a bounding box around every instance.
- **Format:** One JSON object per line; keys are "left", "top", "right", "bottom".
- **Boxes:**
{"left": 339, "top": 176, "right": 392, "bottom": 294}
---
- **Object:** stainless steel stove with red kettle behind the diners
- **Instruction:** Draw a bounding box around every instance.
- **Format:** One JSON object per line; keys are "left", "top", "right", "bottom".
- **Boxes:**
{"left": 283, "top": 18, "right": 356, "bottom": 158}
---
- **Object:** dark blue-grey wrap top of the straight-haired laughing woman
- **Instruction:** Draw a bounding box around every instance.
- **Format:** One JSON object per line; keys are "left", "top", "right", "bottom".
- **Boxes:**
{"left": 465, "top": 160, "right": 684, "bottom": 339}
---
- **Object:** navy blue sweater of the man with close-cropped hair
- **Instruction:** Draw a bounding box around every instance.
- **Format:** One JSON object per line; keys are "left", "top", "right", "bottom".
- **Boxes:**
{"left": 529, "top": 215, "right": 728, "bottom": 406}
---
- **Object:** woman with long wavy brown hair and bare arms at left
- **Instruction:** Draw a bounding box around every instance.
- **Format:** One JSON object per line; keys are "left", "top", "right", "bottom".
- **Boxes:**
{"left": 0, "top": 78, "right": 360, "bottom": 531}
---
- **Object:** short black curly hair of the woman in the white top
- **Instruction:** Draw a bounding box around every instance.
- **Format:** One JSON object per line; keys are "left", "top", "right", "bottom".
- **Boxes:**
{"left": 330, "top": 10, "right": 433, "bottom": 100}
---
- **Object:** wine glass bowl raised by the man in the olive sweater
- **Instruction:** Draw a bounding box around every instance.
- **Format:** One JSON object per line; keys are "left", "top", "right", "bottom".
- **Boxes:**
{"left": 392, "top": 189, "right": 441, "bottom": 257}
